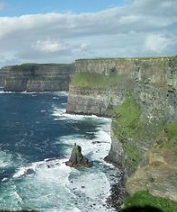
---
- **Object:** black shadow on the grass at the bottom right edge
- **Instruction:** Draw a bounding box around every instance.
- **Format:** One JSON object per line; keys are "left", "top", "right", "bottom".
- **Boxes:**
{"left": 120, "top": 205, "right": 164, "bottom": 212}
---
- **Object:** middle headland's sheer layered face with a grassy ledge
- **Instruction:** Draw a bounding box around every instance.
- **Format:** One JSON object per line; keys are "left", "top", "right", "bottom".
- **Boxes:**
{"left": 67, "top": 59, "right": 136, "bottom": 117}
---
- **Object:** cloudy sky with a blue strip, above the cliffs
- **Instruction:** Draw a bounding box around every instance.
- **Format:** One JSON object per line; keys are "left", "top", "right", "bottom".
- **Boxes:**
{"left": 0, "top": 0, "right": 177, "bottom": 67}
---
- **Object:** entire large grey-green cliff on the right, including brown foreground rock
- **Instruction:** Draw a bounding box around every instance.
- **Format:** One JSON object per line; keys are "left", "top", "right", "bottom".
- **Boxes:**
{"left": 67, "top": 57, "right": 177, "bottom": 207}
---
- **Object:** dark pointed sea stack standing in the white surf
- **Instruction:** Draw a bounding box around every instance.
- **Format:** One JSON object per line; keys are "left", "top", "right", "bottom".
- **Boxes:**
{"left": 65, "top": 143, "right": 92, "bottom": 167}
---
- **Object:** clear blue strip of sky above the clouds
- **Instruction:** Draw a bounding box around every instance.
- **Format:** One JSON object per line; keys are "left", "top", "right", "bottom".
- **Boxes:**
{"left": 1, "top": 0, "right": 125, "bottom": 16}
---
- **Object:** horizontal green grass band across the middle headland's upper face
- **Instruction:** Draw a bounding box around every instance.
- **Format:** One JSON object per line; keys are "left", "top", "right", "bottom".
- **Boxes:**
{"left": 71, "top": 72, "right": 125, "bottom": 88}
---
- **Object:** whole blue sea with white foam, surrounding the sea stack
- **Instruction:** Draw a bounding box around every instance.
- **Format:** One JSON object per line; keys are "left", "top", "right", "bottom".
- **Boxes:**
{"left": 0, "top": 92, "right": 120, "bottom": 212}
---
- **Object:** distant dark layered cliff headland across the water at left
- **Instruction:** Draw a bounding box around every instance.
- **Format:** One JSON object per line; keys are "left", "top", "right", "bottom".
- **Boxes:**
{"left": 4, "top": 64, "right": 74, "bottom": 92}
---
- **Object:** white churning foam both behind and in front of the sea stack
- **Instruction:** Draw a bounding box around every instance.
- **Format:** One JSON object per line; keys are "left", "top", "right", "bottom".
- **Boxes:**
{"left": 14, "top": 118, "right": 114, "bottom": 212}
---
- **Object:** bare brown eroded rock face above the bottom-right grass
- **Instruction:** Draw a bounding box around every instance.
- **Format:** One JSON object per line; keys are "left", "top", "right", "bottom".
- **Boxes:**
{"left": 126, "top": 146, "right": 177, "bottom": 201}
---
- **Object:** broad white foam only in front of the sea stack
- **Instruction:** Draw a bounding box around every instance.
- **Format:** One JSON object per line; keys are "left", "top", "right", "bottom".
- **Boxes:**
{"left": 12, "top": 155, "right": 114, "bottom": 212}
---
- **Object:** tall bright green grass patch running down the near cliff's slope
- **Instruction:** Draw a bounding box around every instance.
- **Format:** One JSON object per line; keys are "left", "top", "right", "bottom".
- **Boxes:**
{"left": 112, "top": 97, "right": 142, "bottom": 172}
